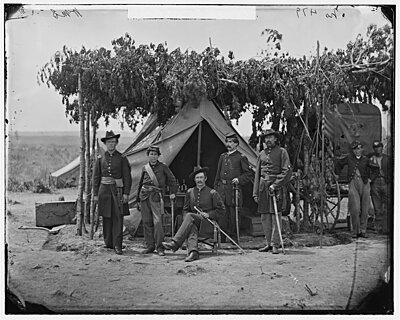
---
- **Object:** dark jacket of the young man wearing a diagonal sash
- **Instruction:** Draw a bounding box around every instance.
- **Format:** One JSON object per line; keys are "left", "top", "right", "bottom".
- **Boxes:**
{"left": 137, "top": 161, "right": 178, "bottom": 201}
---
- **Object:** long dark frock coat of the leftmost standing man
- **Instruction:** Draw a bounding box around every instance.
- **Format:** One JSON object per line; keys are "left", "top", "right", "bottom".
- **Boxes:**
{"left": 93, "top": 150, "right": 132, "bottom": 218}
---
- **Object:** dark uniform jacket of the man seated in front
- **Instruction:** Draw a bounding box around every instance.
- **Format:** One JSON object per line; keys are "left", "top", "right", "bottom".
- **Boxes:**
{"left": 183, "top": 186, "right": 225, "bottom": 235}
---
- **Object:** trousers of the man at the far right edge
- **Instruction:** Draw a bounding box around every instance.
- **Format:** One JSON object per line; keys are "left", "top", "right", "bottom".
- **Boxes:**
{"left": 371, "top": 177, "right": 392, "bottom": 233}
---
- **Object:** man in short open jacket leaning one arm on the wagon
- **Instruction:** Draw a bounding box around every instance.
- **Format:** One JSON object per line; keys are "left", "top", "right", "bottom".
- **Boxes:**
{"left": 335, "top": 140, "right": 371, "bottom": 238}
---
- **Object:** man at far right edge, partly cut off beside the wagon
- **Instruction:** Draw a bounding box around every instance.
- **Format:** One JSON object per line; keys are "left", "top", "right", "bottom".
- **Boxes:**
{"left": 370, "top": 140, "right": 393, "bottom": 233}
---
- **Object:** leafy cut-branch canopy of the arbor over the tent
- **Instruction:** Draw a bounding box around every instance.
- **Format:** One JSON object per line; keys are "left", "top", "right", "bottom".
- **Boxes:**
{"left": 39, "top": 21, "right": 393, "bottom": 235}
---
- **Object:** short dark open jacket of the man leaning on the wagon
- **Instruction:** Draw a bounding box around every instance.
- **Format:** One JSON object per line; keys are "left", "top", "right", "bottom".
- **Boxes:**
{"left": 335, "top": 153, "right": 371, "bottom": 184}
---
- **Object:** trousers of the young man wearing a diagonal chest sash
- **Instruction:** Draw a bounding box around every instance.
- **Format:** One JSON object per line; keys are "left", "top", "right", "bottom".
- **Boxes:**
{"left": 140, "top": 198, "right": 164, "bottom": 250}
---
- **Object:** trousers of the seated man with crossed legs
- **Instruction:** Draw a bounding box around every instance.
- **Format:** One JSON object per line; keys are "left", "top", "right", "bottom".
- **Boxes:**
{"left": 172, "top": 212, "right": 203, "bottom": 253}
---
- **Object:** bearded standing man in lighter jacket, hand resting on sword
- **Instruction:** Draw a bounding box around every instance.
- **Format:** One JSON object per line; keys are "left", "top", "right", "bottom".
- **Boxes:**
{"left": 253, "top": 129, "right": 292, "bottom": 254}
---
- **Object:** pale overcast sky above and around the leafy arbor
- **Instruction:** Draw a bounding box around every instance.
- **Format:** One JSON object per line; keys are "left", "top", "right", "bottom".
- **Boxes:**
{"left": 5, "top": 5, "right": 388, "bottom": 135}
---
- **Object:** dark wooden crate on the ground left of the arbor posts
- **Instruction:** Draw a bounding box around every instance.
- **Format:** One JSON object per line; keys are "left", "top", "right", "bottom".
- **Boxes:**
{"left": 35, "top": 201, "right": 76, "bottom": 227}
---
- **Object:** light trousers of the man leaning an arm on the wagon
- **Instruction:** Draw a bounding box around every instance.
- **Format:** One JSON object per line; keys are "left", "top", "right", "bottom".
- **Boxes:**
{"left": 349, "top": 177, "right": 371, "bottom": 235}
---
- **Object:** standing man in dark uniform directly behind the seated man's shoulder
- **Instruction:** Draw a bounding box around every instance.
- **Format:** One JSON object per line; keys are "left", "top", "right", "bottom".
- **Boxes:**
{"left": 214, "top": 132, "right": 253, "bottom": 242}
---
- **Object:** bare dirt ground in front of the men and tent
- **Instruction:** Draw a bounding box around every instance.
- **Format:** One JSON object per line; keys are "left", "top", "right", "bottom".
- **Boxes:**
{"left": 6, "top": 189, "right": 389, "bottom": 314}
